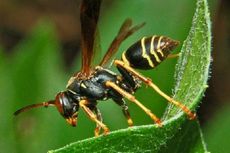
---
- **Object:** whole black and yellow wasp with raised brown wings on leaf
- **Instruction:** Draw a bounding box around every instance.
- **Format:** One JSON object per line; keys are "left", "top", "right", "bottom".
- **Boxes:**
{"left": 14, "top": 0, "right": 196, "bottom": 136}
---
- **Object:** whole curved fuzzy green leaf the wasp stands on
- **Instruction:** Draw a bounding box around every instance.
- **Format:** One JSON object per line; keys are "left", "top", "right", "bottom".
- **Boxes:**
{"left": 49, "top": 0, "right": 211, "bottom": 153}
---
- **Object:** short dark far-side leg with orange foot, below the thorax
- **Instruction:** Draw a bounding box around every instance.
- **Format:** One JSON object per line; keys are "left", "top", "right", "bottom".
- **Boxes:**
{"left": 113, "top": 99, "right": 133, "bottom": 127}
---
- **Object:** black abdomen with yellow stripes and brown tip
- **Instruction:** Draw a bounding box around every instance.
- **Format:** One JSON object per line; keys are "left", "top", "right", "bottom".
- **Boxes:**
{"left": 122, "top": 36, "right": 179, "bottom": 69}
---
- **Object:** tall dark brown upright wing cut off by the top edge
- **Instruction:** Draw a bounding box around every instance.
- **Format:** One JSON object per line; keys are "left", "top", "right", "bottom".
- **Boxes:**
{"left": 80, "top": 0, "right": 101, "bottom": 76}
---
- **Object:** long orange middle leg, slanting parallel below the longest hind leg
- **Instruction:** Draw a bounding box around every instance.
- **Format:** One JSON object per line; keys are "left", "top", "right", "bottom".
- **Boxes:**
{"left": 105, "top": 81, "right": 162, "bottom": 127}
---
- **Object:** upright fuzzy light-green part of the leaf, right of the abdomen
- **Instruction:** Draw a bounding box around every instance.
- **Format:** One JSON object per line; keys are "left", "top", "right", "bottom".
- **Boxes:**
{"left": 165, "top": 0, "right": 211, "bottom": 119}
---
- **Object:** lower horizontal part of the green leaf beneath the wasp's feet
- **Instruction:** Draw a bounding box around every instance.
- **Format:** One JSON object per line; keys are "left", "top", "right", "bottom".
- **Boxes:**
{"left": 49, "top": 118, "right": 206, "bottom": 153}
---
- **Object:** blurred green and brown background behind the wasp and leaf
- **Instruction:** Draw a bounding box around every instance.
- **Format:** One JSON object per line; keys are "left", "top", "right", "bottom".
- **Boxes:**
{"left": 0, "top": 0, "right": 230, "bottom": 153}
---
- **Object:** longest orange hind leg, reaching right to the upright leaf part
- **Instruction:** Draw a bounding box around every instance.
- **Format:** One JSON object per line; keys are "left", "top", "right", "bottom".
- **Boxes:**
{"left": 114, "top": 60, "right": 196, "bottom": 120}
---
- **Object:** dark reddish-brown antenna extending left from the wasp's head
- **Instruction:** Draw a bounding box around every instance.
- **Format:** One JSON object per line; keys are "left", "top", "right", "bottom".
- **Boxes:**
{"left": 14, "top": 100, "right": 55, "bottom": 115}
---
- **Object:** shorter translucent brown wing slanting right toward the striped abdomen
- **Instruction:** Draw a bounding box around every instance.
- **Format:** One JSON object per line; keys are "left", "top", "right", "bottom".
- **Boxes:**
{"left": 99, "top": 19, "right": 145, "bottom": 66}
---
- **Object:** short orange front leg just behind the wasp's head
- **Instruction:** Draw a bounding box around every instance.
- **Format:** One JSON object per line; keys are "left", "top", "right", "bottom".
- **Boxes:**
{"left": 79, "top": 100, "right": 109, "bottom": 135}
